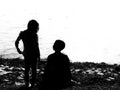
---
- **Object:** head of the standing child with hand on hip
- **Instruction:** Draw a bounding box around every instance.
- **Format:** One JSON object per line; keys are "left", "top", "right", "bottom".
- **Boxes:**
{"left": 28, "top": 20, "right": 39, "bottom": 33}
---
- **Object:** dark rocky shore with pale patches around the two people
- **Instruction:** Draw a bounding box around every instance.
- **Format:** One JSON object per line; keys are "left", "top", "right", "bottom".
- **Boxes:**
{"left": 0, "top": 58, "right": 120, "bottom": 90}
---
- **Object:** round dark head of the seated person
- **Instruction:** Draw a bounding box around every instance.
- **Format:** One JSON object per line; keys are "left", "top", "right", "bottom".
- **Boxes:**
{"left": 53, "top": 40, "right": 65, "bottom": 52}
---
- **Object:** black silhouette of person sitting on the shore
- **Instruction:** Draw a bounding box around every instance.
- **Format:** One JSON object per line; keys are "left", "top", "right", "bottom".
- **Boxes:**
{"left": 40, "top": 40, "right": 71, "bottom": 90}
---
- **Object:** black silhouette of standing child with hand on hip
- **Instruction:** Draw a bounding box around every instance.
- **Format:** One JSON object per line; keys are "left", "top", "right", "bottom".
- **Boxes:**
{"left": 15, "top": 20, "right": 40, "bottom": 87}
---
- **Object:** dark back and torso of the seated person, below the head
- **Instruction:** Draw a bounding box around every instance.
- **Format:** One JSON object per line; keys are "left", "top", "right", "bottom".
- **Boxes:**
{"left": 44, "top": 53, "right": 71, "bottom": 89}
